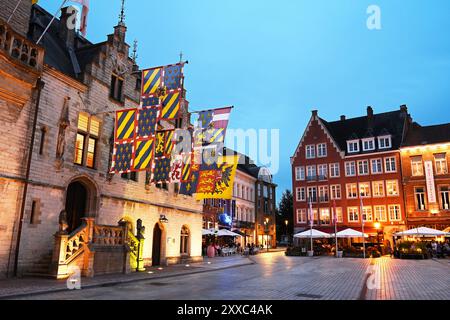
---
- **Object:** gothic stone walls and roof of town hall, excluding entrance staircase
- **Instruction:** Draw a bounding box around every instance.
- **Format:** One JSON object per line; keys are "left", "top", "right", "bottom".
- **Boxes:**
{"left": 0, "top": 0, "right": 202, "bottom": 276}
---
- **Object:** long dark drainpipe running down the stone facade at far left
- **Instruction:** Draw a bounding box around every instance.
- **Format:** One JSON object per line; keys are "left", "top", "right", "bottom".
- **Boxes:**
{"left": 14, "top": 78, "right": 45, "bottom": 277}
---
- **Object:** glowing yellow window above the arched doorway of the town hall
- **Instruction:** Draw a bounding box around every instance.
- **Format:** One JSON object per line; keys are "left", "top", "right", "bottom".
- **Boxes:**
{"left": 74, "top": 113, "right": 100, "bottom": 169}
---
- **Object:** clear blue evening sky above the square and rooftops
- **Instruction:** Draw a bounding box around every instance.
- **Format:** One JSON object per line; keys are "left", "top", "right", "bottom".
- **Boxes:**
{"left": 39, "top": 0, "right": 450, "bottom": 204}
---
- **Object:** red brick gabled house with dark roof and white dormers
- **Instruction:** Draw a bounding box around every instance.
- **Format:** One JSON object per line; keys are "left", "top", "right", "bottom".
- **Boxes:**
{"left": 291, "top": 106, "right": 410, "bottom": 244}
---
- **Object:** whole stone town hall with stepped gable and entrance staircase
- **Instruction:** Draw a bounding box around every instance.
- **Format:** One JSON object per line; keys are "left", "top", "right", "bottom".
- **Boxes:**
{"left": 0, "top": 0, "right": 202, "bottom": 277}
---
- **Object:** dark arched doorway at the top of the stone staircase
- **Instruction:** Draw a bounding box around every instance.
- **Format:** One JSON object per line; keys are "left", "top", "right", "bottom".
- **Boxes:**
{"left": 66, "top": 182, "right": 88, "bottom": 233}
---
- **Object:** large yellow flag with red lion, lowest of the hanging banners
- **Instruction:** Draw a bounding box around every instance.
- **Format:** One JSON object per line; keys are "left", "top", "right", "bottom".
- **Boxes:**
{"left": 195, "top": 156, "right": 239, "bottom": 200}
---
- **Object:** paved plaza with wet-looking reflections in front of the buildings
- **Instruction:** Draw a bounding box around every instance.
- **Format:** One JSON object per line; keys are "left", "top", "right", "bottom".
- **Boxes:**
{"left": 1, "top": 252, "right": 450, "bottom": 300}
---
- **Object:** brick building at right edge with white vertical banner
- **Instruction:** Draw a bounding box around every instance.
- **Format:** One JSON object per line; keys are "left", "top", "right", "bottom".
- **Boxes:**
{"left": 401, "top": 123, "right": 450, "bottom": 230}
